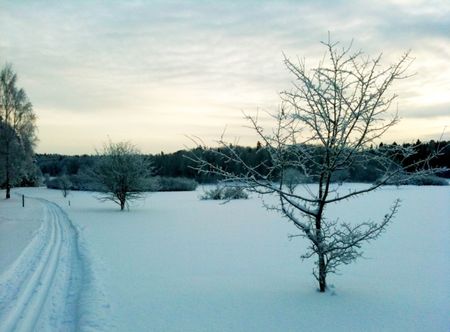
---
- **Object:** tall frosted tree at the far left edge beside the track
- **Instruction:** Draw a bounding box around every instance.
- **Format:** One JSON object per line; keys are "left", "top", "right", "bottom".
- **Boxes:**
{"left": 0, "top": 64, "right": 37, "bottom": 198}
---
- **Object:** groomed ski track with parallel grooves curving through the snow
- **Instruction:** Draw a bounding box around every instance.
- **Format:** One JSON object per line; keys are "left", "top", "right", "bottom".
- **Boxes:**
{"left": 0, "top": 200, "right": 82, "bottom": 331}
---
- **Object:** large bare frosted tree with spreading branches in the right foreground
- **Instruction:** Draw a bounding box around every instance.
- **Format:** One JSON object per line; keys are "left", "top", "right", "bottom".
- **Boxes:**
{"left": 193, "top": 40, "right": 444, "bottom": 292}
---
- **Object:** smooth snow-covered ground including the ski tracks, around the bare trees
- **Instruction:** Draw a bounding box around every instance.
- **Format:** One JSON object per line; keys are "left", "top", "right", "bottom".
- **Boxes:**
{"left": 0, "top": 186, "right": 450, "bottom": 331}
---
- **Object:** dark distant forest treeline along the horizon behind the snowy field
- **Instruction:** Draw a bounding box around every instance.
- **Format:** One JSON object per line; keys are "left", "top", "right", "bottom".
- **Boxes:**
{"left": 36, "top": 140, "right": 450, "bottom": 183}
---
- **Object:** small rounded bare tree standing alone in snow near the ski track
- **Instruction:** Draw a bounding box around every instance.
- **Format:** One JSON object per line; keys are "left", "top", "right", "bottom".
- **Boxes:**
{"left": 91, "top": 142, "right": 152, "bottom": 210}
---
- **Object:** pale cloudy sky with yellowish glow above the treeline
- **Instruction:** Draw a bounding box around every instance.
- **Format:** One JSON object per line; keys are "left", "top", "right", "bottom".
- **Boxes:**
{"left": 0, "top": 0, "right": 450, "bottom": 154}
